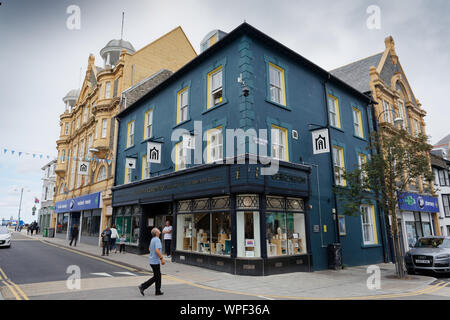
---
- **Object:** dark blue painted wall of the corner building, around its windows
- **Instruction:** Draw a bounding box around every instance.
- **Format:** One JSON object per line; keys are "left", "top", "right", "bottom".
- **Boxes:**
{"left": 116, "top": 36, "right": 383, "bottom": 270}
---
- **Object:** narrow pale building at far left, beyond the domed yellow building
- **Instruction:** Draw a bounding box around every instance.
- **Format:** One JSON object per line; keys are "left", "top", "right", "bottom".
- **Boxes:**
{"left": 38, "top": 160, "right": 56, "bottom": 232}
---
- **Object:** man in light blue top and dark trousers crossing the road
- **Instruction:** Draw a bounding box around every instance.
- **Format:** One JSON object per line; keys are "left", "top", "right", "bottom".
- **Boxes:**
{"left": 138, "top": 228, "right": 166, "bottom": 296}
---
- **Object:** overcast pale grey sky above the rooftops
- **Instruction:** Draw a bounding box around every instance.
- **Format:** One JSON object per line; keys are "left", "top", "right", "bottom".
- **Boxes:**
{"left": 0, "top": 0, "right": 450, "bottom": 222}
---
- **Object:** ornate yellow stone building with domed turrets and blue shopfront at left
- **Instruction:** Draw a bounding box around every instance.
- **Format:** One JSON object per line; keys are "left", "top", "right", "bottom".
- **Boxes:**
{"left": 52, "top": 27, "right": 197, "bottom": 244}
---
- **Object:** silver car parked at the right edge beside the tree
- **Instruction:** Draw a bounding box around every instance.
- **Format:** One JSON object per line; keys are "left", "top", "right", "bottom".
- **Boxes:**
{"left": 405, "top": 236, "right": 450, "bottom": 274}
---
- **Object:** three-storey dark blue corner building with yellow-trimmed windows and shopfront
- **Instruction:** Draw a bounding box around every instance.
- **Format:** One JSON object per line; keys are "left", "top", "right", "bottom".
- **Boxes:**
{"left": 113, "top": 23, "right": 387, "bottom": 275}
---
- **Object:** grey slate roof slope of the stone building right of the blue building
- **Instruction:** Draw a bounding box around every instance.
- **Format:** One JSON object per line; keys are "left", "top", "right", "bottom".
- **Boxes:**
{"left": 330, "top": 52, "right": 384, "bottom": 92}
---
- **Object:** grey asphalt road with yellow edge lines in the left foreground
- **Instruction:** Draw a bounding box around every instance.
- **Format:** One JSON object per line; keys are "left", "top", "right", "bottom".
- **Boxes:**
{"left": 0, "top": 233, "right": 258, "bottom": 300}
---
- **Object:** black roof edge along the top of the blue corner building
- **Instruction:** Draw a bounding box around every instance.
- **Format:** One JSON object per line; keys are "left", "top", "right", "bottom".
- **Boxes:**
{"left": 116, "top": 22, "right": 375, "bottom": 118}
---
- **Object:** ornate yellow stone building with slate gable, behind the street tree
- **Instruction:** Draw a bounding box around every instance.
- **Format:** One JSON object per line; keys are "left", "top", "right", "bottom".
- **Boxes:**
{"left": 331, "top": 36, "right": 440, "bottom": 249}
